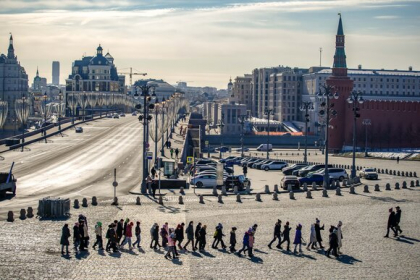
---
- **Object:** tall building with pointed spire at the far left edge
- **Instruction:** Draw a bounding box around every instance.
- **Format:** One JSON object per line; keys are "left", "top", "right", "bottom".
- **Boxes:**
{"left": 0, "top": 35, "right": 28, "bottom": 131}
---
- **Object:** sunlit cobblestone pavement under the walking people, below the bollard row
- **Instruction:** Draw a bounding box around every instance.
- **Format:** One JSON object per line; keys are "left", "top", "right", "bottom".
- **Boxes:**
{"left": 0, "top": 186, "right": 420, "bottom": 279}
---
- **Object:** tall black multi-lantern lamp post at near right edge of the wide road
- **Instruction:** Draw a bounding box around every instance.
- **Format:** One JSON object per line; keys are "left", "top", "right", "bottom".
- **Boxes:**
{"left": 134, "top": 84, "right": 155, "bottom": 194}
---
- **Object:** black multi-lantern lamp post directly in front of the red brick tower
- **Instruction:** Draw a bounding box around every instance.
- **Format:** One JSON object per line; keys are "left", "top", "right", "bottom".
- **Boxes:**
{"left": 317, "top": 85, "right": 338, "bottom": 189}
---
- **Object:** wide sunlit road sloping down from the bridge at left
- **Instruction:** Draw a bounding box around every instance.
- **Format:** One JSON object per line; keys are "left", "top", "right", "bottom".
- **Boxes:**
{"left": 0, "top": 116, "right": 143, "bottom": 217}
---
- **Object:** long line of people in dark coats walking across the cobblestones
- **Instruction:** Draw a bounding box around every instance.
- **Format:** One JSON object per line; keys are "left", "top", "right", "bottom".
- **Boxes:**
{"left": 61, "top": 213, "right": 352, "bottom": 259}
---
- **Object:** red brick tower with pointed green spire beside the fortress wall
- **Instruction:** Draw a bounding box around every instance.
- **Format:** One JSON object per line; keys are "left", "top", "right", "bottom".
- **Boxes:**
{"left": 327, "top": 14, "right": 353, "bottom": 150}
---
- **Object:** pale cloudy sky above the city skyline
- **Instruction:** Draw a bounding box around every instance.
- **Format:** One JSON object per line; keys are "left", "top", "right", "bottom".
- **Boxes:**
{"left": 0, "top": 0, "right": 420, "bottom": 88}
